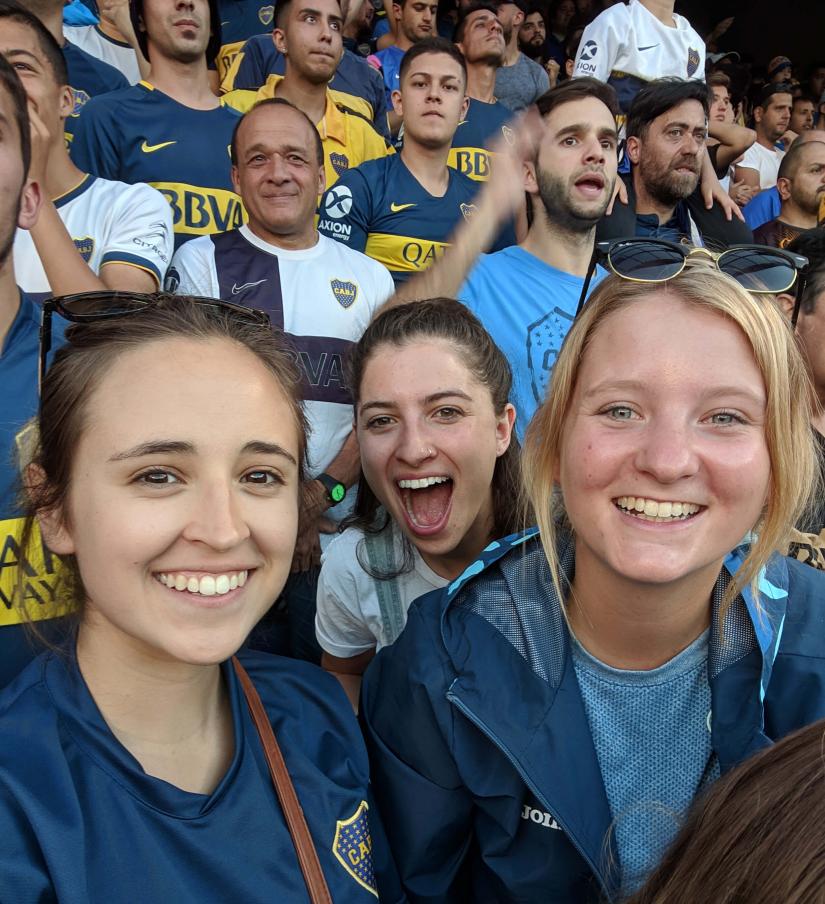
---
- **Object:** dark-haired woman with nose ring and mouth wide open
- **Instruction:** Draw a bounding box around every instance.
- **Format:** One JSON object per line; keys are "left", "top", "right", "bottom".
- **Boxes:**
{"left": 315, "top": 299, "right": 523, "bottom": 707}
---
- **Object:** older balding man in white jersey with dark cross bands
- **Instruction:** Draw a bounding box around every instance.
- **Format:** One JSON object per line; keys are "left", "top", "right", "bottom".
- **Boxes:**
{"left": 167, "top": 98, "right": 393, "bottom": 662}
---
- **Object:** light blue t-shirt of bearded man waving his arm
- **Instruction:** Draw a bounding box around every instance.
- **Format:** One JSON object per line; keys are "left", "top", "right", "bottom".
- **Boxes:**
{"left": 458, "top": 245, "right": 607, "bottom": 442}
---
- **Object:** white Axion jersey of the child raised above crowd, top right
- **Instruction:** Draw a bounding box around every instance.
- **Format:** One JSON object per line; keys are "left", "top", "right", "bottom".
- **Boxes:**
{"left": 573, "top": 0, "right": 705, "bottom": 113}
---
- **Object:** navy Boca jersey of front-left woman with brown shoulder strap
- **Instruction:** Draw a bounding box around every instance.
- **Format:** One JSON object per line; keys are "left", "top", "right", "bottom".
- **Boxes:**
{"left": 0, "top": 651, "right": 402, "bottom": 904}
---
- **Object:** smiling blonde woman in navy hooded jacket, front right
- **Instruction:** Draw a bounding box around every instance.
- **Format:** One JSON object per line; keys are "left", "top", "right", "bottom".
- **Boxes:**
{"left": 361, "top": 264, "right": 825, "bottom": 904}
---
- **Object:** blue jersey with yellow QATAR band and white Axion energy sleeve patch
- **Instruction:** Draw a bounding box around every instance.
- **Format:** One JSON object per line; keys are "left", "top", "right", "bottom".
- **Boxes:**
{"left": 318, "top": 154, "right": 478, "bottom": 283}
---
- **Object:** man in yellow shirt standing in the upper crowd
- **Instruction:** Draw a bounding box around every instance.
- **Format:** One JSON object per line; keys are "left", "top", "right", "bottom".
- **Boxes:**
{"left": 223, "top": 0, "right": 389, "bottom": 187}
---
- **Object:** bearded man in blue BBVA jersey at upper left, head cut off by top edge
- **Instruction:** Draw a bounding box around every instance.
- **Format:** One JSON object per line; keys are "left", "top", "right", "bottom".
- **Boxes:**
{"left": 71, "top": 0, "right": 243, "bottom": 247}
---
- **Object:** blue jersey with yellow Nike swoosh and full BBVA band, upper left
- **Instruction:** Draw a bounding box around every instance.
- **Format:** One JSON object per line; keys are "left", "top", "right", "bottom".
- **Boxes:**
{"left": 71, "top": 82, "right": 243, "bottom": 247}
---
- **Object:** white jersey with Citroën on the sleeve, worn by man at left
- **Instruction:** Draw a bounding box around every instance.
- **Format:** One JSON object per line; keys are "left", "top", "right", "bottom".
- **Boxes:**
{"left": 14, "top": 175, "right": 175, "bottom": 294}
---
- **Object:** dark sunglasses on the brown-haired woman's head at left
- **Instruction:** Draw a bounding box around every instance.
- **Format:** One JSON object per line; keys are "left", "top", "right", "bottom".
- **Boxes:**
{"left": 38, "top": 291, "right": 270, "bottom": 389}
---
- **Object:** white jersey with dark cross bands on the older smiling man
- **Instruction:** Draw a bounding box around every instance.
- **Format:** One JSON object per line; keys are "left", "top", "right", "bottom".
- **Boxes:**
{"left": 167, "top": 226, "right": 395, "bottom": 520}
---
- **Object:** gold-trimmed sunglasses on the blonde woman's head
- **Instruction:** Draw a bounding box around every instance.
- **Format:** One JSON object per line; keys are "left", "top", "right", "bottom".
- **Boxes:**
{"left": 576, "top": 238, "right": 808, "bottom": 326}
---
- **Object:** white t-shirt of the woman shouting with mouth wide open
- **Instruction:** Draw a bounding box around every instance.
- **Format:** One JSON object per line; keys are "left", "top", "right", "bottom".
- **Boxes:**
{"left": 315, "top": 521, "right": 449, "bottom": 659}
